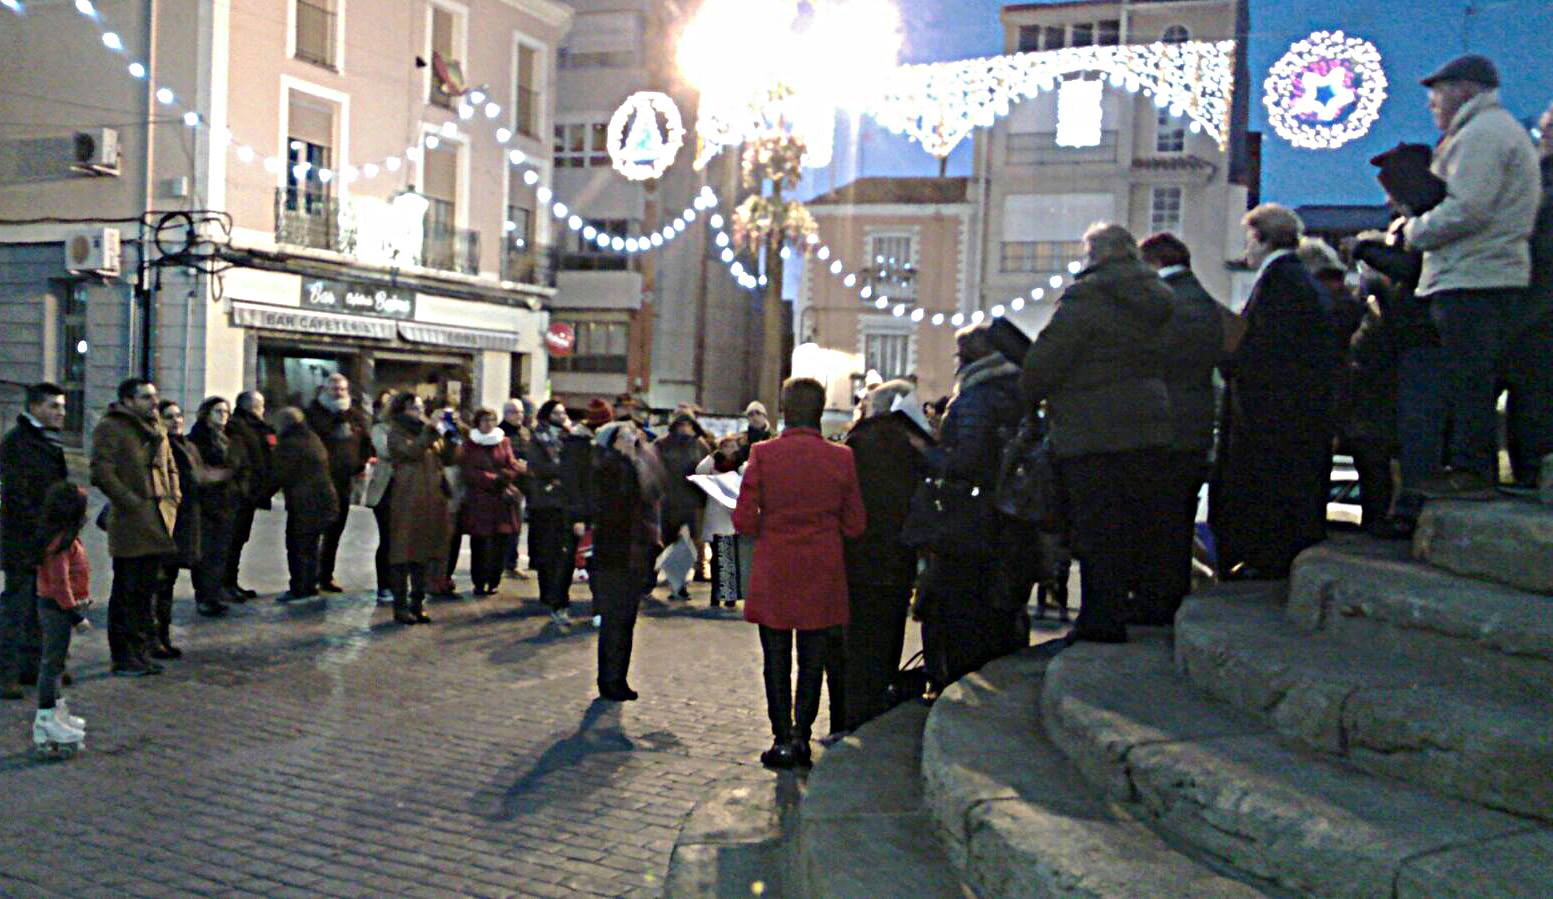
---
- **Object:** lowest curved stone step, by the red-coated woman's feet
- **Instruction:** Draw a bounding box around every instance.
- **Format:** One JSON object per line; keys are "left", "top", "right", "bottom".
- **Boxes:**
{"left": 787, "top": 702, "right": 966, "bottom": 899}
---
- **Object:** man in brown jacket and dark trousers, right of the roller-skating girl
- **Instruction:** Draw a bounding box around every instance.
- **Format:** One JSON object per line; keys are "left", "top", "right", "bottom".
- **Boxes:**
{"left": 92, "top": 377, "right": 183, "bottom": 677}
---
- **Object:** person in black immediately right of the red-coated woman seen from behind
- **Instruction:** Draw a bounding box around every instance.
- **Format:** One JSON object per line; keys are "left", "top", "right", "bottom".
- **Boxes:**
{"left": 826, "top": 380, "right": 927, "bottom": 731}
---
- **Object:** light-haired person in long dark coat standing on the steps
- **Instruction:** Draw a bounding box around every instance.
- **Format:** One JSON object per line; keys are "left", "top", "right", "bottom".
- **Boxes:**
{"left": 1210, "top": 203, "right": 1340, "bottom": 579}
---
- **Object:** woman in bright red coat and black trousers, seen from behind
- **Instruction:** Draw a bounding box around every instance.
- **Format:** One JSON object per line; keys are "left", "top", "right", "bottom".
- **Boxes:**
{"left": 733, "top": 377, "right": 868, "bottom": 769}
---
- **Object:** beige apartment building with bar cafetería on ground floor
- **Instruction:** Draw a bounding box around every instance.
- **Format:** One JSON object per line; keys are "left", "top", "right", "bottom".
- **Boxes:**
{"left": 0, "top": 0, "right": 573, "bottom": 441}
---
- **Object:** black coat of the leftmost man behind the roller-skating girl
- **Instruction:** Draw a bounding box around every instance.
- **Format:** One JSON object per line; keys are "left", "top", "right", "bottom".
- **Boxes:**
{"left": 0, "top": 415, "right": 68, "bottom": 571}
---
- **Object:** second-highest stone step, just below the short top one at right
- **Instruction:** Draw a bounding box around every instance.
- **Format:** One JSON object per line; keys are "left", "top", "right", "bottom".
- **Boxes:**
{"left": 1287, "top": 542, "right": 1553, "bottom": 689}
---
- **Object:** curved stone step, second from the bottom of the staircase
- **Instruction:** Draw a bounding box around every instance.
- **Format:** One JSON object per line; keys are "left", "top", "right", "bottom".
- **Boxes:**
{"left": 922, "top": 649, "right": 1264, "bottom": 899}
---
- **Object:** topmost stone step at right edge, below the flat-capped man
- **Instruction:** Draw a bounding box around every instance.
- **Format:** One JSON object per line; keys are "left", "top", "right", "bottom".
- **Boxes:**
{"left": 1413, "top": 500, "right": 1553, "bottom": 595}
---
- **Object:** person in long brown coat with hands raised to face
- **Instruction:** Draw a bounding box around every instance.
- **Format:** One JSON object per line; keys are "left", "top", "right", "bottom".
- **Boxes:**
{"left": 388, "top": 393, "right": 453, "bottom": 624}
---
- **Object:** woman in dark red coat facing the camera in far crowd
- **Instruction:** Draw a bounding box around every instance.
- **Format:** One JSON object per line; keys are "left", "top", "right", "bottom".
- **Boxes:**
{"left": 458, "top": 408, "right": 528, "bottom": 596}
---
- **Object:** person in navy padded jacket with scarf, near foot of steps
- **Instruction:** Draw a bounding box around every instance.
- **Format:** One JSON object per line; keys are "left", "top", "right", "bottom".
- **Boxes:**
{"left": 913, "top": 325, "right": 1028, "bottom": 689}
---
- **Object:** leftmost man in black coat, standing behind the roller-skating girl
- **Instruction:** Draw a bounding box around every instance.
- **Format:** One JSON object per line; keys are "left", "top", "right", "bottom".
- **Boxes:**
{"left": 0, "top": 384, "right": 67, "bottom": 699}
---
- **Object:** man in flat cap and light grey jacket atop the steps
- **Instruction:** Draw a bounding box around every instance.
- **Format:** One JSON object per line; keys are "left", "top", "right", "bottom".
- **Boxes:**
{"left": 1399, "top": 54, "right": 1541, "bottom": 503}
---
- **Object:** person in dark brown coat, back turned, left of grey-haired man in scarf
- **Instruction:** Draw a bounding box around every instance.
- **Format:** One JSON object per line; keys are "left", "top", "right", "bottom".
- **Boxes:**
{"left": 275, "top": 407, "right": 340, "bottom": 602}
